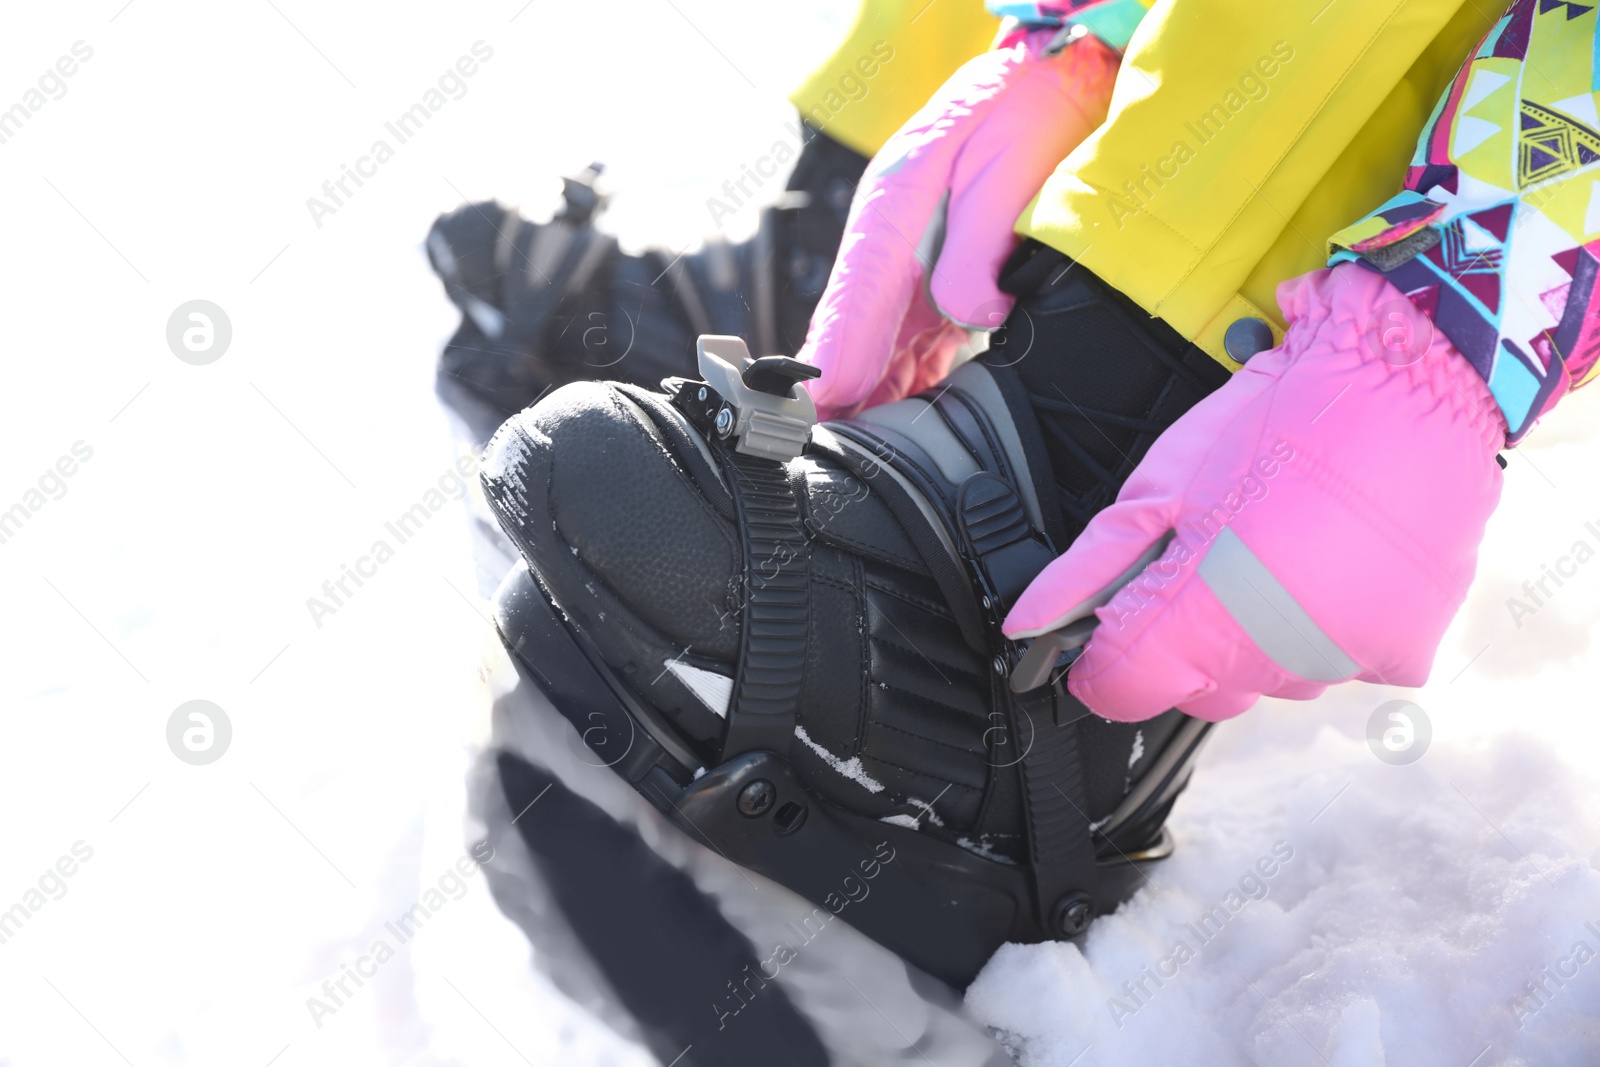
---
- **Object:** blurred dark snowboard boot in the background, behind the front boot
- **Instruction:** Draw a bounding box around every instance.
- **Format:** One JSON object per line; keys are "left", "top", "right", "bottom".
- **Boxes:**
{"left": 427, "top": 126, "right": 867, "bottom": 442}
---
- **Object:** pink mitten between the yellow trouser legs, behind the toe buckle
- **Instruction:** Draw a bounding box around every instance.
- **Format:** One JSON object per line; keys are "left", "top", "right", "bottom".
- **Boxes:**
{"left": 800, "top": 29, "right": 1118, "bottom": 419}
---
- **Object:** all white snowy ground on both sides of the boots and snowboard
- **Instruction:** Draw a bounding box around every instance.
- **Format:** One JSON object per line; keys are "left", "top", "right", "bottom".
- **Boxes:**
{"left": 0, "top": 0, "right": 1600, "bottom": 1067}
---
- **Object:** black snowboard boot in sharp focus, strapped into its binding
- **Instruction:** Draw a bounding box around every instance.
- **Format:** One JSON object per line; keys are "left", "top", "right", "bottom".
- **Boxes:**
{"left": 483, "top": 252, "right": 1210, "bottom": 985}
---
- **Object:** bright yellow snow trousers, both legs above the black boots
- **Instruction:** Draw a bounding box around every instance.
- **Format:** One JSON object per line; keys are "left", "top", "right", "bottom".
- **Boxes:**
{"left": 792, "top": 0, "right": 1502, "bottom": 368}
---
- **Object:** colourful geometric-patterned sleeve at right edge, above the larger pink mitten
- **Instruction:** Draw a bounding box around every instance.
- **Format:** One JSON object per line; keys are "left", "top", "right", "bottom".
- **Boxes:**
{"left": 1330, "top": 0, "right": 1600, "bottom": 443}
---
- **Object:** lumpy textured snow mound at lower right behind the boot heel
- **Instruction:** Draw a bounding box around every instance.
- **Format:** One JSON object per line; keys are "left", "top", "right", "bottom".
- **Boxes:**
{"left": 968, "top": 700, "right": 1600, "bottom": 1067}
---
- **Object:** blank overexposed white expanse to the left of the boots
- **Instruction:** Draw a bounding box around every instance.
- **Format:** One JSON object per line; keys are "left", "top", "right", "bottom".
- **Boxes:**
{"left": 0, "top": 0, "right": 853, "bottom": 1067}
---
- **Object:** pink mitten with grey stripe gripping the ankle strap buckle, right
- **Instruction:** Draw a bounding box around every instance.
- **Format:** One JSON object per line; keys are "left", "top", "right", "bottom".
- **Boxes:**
{"left": 1005, "top": 264, "right": 1506, "bottom": 721}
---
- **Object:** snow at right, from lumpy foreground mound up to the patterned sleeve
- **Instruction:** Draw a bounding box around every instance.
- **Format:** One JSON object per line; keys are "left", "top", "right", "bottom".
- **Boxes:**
{"left": 968, "top": 403, "right": 1600, "bottom": 1067}
